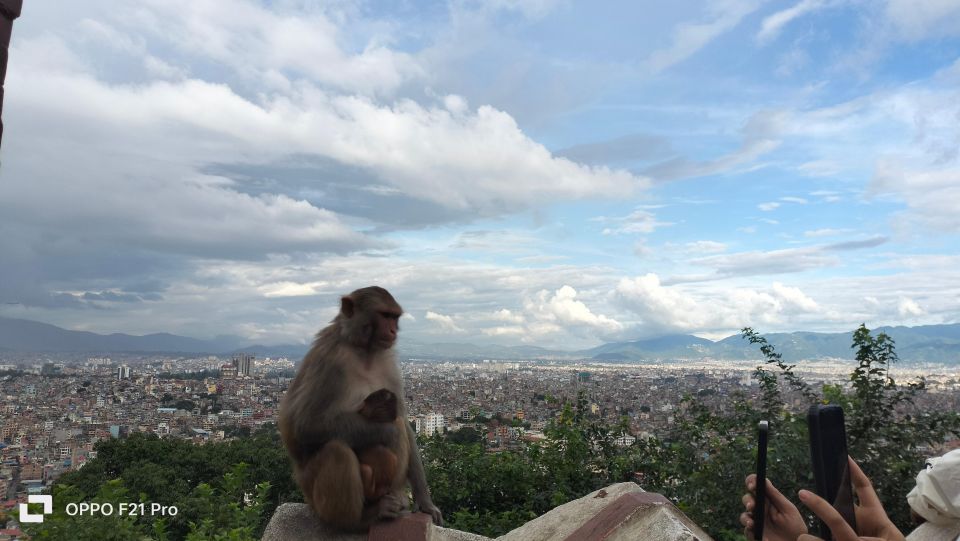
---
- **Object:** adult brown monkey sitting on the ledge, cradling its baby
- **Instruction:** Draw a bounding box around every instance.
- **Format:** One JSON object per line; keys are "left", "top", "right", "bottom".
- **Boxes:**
{"left": 279, "top": 286, "right": 443, "bottom": 530}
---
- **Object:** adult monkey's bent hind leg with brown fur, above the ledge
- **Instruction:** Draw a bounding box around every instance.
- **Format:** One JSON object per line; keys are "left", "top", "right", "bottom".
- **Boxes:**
{"left": 301, "top": 440, "right": 364, "bottom": 530}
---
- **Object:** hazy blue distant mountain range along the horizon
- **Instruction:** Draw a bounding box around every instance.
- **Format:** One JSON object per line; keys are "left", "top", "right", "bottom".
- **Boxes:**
{"left": 0, "top": 317, "right": 960, "bottom": 364}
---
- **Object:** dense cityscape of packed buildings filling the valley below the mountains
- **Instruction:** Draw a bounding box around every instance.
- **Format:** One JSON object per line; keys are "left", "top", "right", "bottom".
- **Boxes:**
{"left": 0, "top": 348, "right": 960, "bottom": 532}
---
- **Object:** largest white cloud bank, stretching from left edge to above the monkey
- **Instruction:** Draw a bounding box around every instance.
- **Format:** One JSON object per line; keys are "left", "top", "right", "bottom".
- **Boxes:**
{"left": 0, "top": 23, "right": 645, "bottom": 272}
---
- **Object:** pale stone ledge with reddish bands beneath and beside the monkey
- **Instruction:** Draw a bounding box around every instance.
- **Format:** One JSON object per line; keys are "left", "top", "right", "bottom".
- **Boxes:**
{"left": 262, "top": 483, "right": 712, "bottom": 541}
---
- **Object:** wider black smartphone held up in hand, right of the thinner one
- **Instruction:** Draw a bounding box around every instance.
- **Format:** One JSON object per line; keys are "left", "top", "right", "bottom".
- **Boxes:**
{"left": 807, "top": 404, "right": 857, "bottom": 541}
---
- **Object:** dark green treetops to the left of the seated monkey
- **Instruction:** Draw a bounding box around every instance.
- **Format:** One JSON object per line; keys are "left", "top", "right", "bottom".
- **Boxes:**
{"left": 45, "top": 427, "right": 300, "bottom": 540}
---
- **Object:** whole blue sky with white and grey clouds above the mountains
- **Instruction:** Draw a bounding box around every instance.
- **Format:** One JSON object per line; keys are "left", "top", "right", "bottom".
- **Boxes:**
{"left": 0, "top": 0, "right": 960, "bottom": 349}
